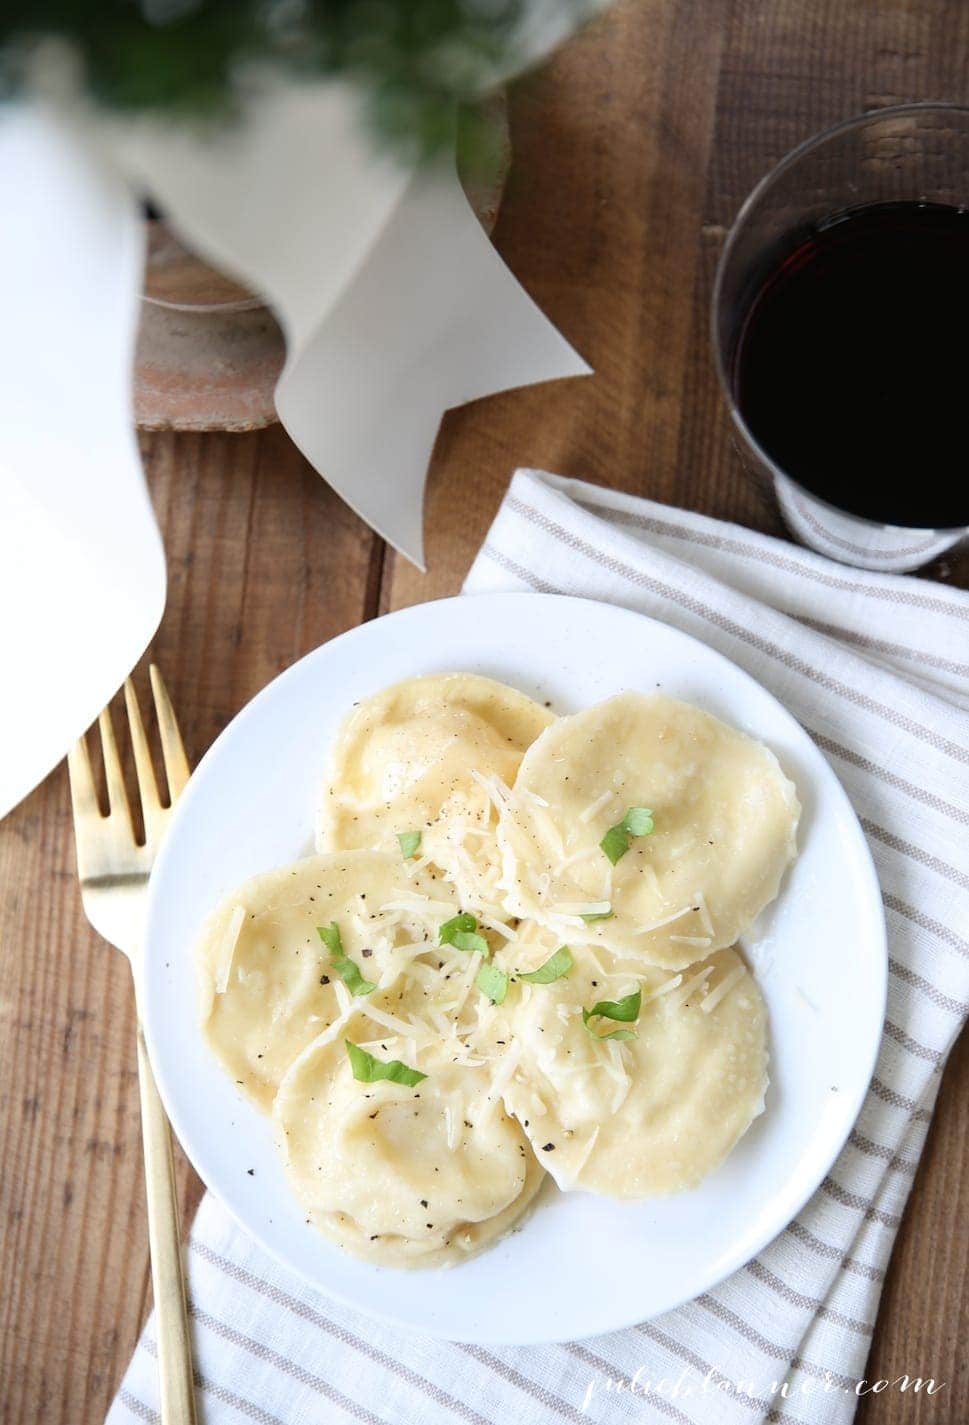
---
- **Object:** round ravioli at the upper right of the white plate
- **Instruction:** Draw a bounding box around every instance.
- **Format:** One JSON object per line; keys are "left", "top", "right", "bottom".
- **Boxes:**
{"left": 497, "top": 693, "right": 801, "bottom": 969}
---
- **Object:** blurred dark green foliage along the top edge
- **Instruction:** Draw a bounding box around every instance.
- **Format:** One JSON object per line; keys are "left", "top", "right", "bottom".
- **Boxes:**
{"left": 0, "top": 0, "right": 538, "bottom": 157}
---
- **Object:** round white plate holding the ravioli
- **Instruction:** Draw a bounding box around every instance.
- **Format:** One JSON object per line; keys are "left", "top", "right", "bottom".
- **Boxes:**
{"left": 145, "top": 594, "right": 886, "bottom": 1345}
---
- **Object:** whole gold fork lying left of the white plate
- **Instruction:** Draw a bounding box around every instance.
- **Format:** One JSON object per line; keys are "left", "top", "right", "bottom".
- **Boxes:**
{"left": 67, "top": 664, "right": 195, "bottom": 1425}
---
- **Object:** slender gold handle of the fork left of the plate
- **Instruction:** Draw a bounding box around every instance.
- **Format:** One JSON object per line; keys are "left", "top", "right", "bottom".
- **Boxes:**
{"left": 138, "top": 1019, "right": 197, "bottom": 1425}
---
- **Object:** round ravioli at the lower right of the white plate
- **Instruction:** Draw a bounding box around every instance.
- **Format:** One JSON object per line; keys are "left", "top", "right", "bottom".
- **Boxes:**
{"left": 492, "top": 948, "right": 767, "bottom": 1198}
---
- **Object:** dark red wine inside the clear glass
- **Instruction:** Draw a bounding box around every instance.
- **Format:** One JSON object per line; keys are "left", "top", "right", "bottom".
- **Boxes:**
{"left": 731, "top": 202, "right": 969, "bottom": 529}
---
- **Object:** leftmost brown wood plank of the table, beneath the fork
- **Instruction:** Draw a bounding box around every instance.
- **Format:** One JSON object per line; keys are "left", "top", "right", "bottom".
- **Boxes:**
{"left": 0, "top": 428, "right": 382, "bottom": 1425}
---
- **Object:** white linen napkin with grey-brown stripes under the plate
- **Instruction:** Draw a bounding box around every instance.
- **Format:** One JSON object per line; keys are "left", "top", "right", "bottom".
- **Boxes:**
{"left": 108, "top": 470, "right": 969, "bottom": 1425}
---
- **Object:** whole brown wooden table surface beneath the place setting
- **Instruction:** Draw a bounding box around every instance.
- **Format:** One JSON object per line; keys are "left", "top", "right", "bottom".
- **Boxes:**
{"left": 0, "top": 0, "right": 969, "bottom": 1425}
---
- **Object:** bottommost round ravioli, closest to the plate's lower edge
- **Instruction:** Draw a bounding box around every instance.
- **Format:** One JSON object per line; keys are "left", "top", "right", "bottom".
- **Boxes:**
{"left": 274, "top": 1026, "right": 543, "bottom": 1267}
